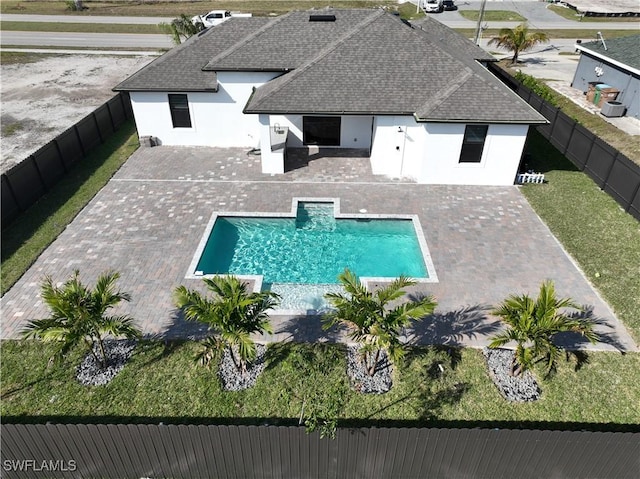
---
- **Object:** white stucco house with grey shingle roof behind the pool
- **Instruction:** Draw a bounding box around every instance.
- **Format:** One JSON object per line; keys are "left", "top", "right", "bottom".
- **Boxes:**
{"left": 115, "top": 9, "right": 546, "bottom": 185}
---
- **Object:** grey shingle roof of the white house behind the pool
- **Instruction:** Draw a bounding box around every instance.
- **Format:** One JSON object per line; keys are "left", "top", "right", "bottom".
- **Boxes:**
{"left": 116, "top": 9, "right": 546, "bottom": 124}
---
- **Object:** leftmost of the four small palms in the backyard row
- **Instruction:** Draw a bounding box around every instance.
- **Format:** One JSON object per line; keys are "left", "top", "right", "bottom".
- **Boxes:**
{"left": 22, "top": 270, "right": 141, "bottom": 368}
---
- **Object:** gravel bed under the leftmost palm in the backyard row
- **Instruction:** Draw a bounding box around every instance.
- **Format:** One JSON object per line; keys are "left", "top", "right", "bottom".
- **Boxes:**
{"left": 76, "top": 339, "right": 137, "bottom": 386}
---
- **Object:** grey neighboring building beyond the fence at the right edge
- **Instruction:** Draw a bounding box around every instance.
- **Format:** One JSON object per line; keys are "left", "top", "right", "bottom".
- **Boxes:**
{"left": 571, "top": 35, "right": 640, "bottom": 118}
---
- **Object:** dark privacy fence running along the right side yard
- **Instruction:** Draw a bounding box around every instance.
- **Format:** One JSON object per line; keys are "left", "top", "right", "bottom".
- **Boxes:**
{"left": 489, "top": 64, "right": 640, "bottom": 220}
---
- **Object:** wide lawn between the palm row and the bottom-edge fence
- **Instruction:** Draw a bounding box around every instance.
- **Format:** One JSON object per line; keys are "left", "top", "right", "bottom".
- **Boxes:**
{"left": 0, "top": 341, "right": 640, "bottom": 430}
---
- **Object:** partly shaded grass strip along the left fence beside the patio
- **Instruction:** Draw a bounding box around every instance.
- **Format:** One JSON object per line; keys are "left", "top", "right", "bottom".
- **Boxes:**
{"left": 1, "top": 121, "right": 139, "bottom": 294}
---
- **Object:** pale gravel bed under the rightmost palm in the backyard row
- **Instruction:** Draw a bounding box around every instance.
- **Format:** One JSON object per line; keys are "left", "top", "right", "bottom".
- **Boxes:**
{"left": 482, "top": 348, "right": 541, "bottom": 402}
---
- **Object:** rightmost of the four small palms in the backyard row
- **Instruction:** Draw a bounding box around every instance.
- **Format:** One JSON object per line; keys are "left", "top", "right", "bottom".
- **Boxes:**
{"left": 489, "top": 281, "right": 598, "bottom": 376}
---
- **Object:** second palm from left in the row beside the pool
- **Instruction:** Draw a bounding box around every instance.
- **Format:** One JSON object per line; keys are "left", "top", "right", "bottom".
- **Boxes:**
{"left": 174, "top": 276, "right": 279, "bottom": 374}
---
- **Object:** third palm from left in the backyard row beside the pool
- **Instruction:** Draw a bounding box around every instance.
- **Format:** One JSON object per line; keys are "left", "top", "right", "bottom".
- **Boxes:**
{"left": 323, "top": 269, "right": 436, "bottom": 376}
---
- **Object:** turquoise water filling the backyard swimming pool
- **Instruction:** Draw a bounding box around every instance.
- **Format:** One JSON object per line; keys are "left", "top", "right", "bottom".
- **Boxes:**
{"left": 192, "top": 202, "right": 428, "bottom": 284}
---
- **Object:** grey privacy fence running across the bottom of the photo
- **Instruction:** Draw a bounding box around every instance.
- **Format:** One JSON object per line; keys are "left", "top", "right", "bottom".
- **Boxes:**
{"left": 1, "top": 424, "right": 640, "bottom": 479}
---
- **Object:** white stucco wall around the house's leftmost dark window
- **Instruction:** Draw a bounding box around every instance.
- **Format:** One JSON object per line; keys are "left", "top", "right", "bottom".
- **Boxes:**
{"left": 131, "top": 72, "right": 277, "bottom": 147}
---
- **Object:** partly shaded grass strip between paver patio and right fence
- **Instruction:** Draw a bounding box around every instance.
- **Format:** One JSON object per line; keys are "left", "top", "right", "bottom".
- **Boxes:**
{"left": 522, "top": 131, "right": 640, "bottom": 344}
